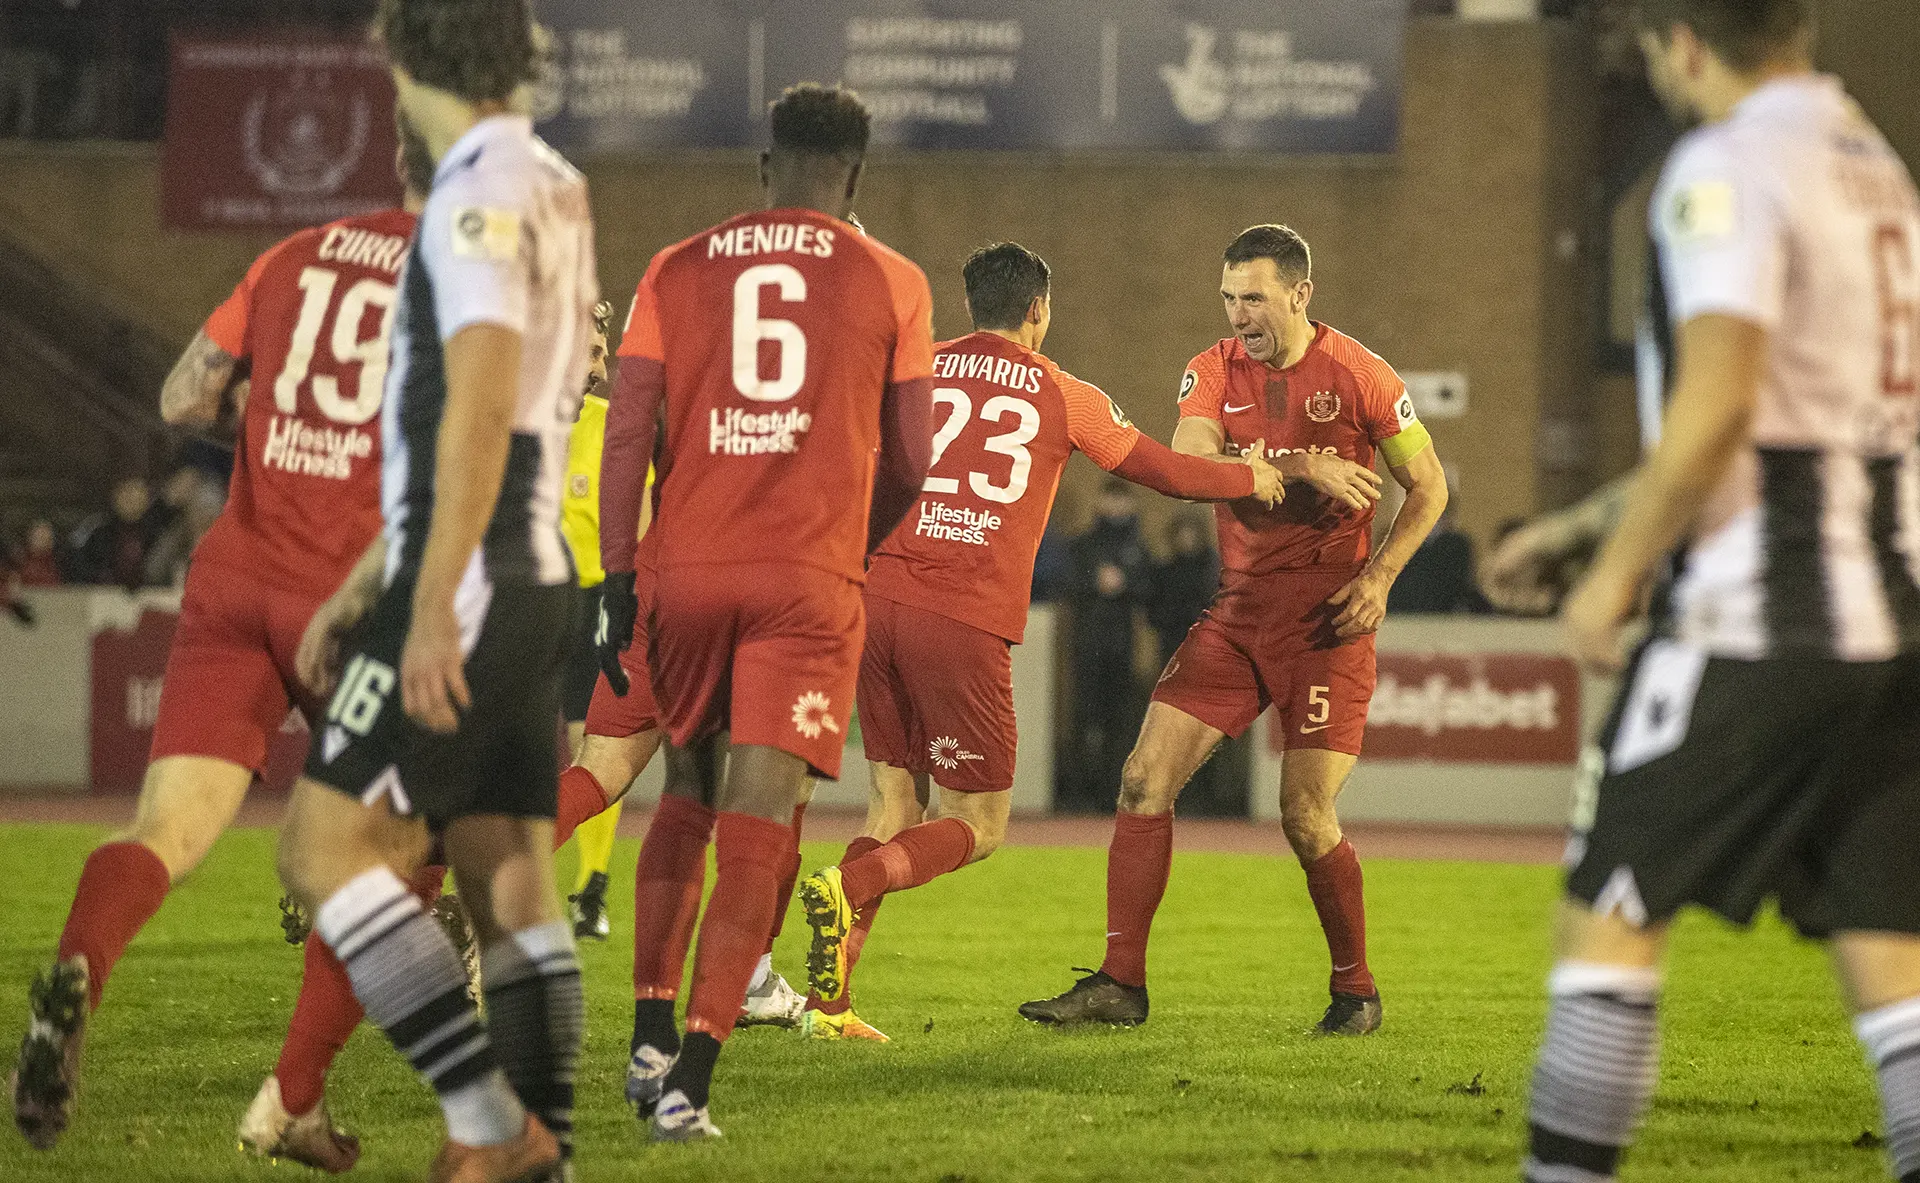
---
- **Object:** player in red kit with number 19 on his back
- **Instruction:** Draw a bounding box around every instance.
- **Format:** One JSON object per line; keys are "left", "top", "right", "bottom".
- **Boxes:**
{"left": 10, "top": 136, "right": 434, "bottom": 1170}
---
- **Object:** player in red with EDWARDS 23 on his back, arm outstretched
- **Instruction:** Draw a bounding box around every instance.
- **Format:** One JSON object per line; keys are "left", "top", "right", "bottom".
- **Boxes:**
{"left": 801, "top": 242, "right": 1281, "bottom": 1041}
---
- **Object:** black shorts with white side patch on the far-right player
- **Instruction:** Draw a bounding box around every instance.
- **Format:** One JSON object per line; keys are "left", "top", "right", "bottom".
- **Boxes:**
{"left": 1567, "top": 641, "right": 1920, "bottom": 937}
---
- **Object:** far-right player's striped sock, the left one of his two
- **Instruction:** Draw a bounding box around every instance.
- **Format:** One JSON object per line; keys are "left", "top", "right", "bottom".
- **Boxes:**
{"left": 1523, "top": 962, "right": 1661, "bottom": 1183}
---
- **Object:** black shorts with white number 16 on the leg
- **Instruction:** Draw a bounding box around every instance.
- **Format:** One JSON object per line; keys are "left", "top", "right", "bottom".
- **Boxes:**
{"left": 307, "top": 580, "right": 580, "bottom": 826}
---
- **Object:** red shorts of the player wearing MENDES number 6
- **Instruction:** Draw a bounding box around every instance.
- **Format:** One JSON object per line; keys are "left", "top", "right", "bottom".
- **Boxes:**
{"left": 647, "top": 563, "right": 866, "bottom": 780}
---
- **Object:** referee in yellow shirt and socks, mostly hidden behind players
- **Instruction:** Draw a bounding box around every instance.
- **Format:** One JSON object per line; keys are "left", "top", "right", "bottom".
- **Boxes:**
{"left": 561, "top": 300, "right": 620, "bottom": 941}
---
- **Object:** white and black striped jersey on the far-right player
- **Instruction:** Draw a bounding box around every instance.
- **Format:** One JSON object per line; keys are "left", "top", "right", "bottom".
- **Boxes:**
{"left": 1651, "top": 75, "right": 1920, "bottom": 661}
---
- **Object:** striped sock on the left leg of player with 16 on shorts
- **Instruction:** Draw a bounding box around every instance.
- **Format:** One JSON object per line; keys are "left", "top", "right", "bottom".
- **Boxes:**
{"left": 313, "top": 866, "right": 526, "bottom": 1147}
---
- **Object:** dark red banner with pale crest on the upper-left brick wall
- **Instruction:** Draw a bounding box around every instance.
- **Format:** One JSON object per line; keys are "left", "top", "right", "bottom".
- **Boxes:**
{"left": 159, "top": 33, "right": 399, "bottom": 230}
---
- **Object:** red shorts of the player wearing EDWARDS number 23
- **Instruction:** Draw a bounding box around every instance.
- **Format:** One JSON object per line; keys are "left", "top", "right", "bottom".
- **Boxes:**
{"left": 860, "top": 595, "right": 1020, "bottom": 793}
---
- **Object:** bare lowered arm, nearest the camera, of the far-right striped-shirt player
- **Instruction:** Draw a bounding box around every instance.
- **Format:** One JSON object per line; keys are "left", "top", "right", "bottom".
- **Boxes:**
{"left": 1561, "top": 313, "right": 1766, "bottom": 670}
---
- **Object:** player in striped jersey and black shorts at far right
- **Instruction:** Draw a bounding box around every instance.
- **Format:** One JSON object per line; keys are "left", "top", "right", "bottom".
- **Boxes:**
{"left": 1524, "top": 0, "right": 1920, "bottom": 1183}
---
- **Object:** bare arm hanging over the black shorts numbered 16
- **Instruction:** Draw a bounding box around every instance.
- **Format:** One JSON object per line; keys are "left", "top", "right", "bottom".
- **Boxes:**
{"left": 399, "top": 321, "right": 520, "bottom": 734}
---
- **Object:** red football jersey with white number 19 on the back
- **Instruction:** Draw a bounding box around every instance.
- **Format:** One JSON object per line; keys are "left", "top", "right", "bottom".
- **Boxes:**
{"left": 194, "top": 209, "right": 415, "bottom": 593}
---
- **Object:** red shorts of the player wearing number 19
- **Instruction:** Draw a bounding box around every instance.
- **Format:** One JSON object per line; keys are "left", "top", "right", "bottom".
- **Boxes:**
{"left": 148, "top": 563, "right": 326, "bottom": 774}
